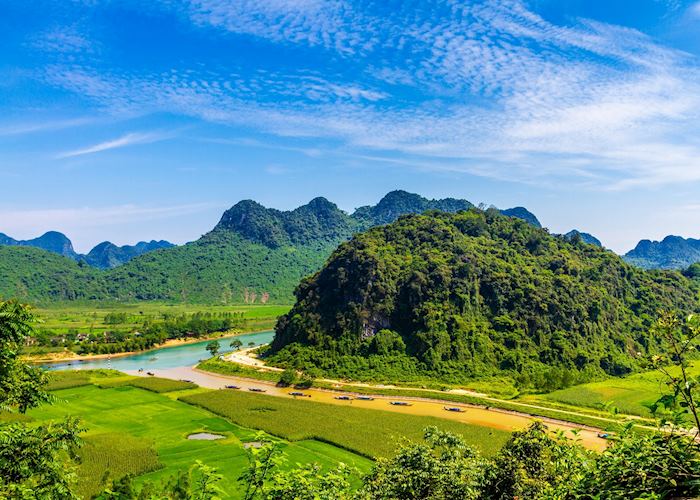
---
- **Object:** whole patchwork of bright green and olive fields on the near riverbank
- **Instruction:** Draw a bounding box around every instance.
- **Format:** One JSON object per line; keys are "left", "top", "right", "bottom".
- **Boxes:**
{"left": 27, "top": 370, "right": 509, "bottom": 498}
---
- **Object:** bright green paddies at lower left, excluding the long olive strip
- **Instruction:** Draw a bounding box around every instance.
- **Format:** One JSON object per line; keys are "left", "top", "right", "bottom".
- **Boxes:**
{"left": 29, "top": 385, "right": 371, "bottom": 498}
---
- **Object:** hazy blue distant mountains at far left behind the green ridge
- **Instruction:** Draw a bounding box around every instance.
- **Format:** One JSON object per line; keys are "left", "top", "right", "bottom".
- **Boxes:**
{"left": 0, "top": 231, "right": 175, "bottom": 269}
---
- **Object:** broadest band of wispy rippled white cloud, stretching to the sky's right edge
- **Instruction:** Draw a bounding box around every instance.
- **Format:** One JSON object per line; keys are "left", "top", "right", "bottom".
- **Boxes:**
{"left": 41, "top": 0, "right": 700, "bottom": 189}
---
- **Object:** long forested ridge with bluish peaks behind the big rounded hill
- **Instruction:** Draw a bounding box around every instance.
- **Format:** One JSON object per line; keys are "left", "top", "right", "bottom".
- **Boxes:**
{"left": 0, "top": 191, "right": 536, "bottom": 303}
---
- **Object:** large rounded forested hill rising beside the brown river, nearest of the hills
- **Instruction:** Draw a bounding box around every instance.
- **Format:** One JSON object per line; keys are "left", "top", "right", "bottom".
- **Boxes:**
{"left": 271, "top": 210, "right": 698, "bottom": 385}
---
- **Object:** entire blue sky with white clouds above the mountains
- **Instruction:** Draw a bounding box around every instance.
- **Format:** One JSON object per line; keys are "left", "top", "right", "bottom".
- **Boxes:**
{"left": 0, "top": 0, "right": 700, "bottom": 252}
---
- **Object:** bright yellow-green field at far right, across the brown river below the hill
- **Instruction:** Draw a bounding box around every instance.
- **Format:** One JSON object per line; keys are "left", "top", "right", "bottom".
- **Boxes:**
{"left": 529, "top": 361, "right": 700, "bottom": 417}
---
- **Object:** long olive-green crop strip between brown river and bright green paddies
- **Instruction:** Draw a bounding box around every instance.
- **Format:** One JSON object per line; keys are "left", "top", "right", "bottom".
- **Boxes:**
{"left": 180, "top": 391, "right": 510, "bottom": 458}
